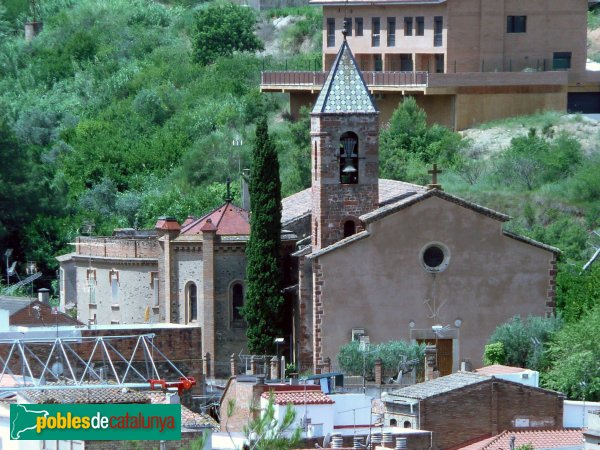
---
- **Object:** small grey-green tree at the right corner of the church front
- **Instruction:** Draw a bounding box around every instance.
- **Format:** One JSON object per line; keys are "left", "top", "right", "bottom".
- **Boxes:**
{"left": 488, "top": 316, "right": 562, "bottom": 370}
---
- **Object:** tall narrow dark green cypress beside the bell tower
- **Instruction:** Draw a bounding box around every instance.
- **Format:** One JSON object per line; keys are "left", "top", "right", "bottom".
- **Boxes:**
{"left": 242, "top": 115, "right": 283, "bottom": 354}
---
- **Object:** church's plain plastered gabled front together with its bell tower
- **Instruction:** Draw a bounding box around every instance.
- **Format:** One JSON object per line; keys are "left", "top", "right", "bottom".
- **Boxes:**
{"left": 284, "top": 41, "right": 558, "bottom": 374}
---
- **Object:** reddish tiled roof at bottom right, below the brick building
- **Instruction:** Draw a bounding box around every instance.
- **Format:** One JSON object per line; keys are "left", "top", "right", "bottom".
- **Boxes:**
{"left": 458, "top": 429, "right": 583, "bottom": 450}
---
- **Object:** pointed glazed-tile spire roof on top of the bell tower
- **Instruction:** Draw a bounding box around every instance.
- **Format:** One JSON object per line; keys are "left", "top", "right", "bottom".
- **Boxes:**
{"left": 313, "top": 41, "right": 377, "bottom": 113}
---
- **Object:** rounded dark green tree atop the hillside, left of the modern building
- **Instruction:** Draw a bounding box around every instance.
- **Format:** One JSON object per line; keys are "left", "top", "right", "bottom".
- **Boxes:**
{"left": 193, "top": 3, "right": 264, "bottom": 65}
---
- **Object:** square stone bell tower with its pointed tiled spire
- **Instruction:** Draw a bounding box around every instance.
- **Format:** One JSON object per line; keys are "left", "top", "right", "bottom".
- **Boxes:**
{"left": 311, "top": 39, "right": 379, "bottom": 251}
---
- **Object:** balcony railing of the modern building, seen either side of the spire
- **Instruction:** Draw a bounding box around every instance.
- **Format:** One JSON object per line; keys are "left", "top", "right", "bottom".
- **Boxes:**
{"left": 260, "top": 71, "right": 429, "bottom": 88}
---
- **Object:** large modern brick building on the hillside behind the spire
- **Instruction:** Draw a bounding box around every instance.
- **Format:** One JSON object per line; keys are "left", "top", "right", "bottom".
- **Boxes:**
{"left": 261, "top": 0, "right": 600, "bottom": 130}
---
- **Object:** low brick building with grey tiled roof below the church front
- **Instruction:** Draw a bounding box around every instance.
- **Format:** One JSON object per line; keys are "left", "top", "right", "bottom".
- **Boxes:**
{"left": 382, "top": 372, "right": 564, "bottom": 449}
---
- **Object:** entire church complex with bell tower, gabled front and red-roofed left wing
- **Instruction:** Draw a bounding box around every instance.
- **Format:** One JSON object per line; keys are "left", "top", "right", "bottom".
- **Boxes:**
{"left": 58, "top": 40, "right": 559, "bottom": 376}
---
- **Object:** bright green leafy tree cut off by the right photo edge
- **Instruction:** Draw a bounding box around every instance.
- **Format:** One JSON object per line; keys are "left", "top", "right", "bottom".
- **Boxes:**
{"left": 542, "top": 305, "right": 600, "bottom": 401}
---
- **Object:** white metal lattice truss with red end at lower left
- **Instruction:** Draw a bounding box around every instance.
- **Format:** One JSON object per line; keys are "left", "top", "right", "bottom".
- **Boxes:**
{"left": 0, "top": 333, "right": 195, "bottom": 392}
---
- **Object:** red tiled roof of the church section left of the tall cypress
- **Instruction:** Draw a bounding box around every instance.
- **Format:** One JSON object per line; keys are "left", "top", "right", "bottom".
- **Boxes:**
{"left": 181, "top": 202, "right": 250, "bottom": 236}
